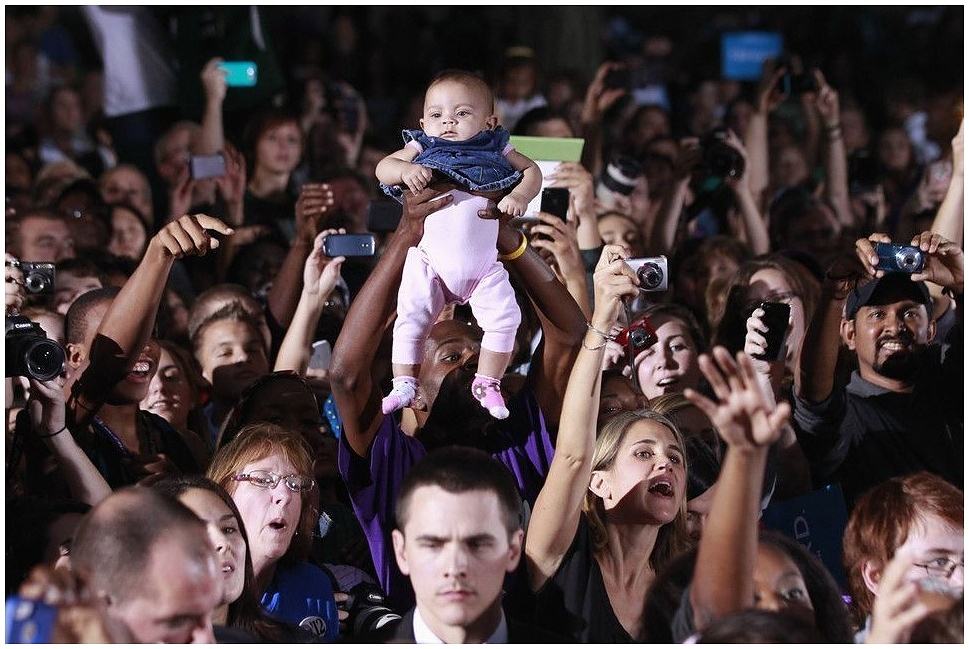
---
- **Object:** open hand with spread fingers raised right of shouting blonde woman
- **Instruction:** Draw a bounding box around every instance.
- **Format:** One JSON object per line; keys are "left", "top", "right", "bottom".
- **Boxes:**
{"left": 684, "top": 347, "right": 791, "bottom": 451}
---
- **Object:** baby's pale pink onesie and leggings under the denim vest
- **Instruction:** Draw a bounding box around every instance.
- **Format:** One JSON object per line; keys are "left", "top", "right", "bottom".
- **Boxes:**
{"left": 391, "top": 142, "right": 521, "bottom": 365}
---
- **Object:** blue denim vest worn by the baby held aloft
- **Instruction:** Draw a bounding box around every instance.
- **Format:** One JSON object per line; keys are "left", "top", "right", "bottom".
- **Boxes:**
{"left": 380, "top": 126, "right": 522, "bottom": 202}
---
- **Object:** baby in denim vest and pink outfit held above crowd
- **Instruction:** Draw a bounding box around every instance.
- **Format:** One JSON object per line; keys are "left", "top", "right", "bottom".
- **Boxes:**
{"left": 376, "top": 70, "right": 542, "bottom": 419}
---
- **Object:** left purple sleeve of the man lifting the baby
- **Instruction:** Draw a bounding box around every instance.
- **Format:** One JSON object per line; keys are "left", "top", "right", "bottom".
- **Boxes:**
{"left": 337, "top": 417, "right": 427, "bottom": 601}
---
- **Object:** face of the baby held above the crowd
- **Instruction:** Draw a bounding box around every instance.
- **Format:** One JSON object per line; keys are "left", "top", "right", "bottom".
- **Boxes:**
{"left": 421, "top": 81, "right": 498, "bottom": 142}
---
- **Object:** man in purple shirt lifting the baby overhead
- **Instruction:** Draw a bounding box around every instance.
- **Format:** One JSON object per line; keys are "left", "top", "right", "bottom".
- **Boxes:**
{"left": 330, "top": 188, "right": 585, "bottom": 609}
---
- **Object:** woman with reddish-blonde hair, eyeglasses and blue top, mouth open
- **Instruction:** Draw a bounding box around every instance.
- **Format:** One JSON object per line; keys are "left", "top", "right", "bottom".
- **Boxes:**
{"left": 207, "top": 423, "right": 338, "bottom": 642}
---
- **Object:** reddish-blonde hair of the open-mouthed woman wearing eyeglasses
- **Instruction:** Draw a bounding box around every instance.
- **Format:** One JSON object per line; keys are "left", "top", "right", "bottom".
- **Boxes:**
{"left": 205, "top": 422, "right": 317, "bottom": 563}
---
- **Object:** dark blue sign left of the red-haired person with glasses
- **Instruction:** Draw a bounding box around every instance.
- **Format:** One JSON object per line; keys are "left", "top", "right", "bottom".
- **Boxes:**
{"left": 761, "top": 485, "right": 848, "bottom": 588}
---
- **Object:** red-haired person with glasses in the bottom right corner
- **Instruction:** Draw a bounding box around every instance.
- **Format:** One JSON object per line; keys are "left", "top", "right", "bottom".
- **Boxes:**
{"left": 843, "top": 471, "right": 966, "bottom": 643}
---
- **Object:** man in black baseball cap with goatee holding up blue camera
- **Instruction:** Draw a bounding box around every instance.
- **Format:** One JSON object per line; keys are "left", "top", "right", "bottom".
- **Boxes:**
{"left": 794, "top": 232, "right": 964, "bottom": 506}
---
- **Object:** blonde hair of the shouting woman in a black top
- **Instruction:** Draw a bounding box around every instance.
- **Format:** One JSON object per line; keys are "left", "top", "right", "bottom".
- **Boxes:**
{"left": 582, "top": 410, "right": 689, "bottom": 570}
